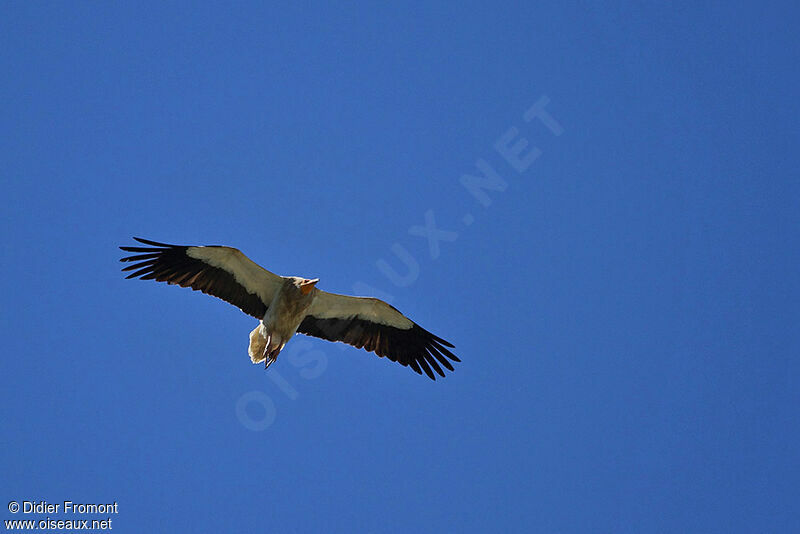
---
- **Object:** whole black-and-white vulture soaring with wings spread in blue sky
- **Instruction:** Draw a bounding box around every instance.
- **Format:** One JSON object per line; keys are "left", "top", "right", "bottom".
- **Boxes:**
{"left": 119, "top": 237, "right": 461, "bottom": 380}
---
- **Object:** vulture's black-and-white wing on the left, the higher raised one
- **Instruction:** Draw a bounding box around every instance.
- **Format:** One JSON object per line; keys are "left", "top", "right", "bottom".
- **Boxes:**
{"left": 119, "top": 237, "right": 283, "bottom": 319}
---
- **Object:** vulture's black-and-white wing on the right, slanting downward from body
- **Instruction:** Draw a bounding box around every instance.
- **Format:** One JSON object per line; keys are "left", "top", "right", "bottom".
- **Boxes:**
{"left": 297, "top": 290, "right": 461, "bottom": 380}
